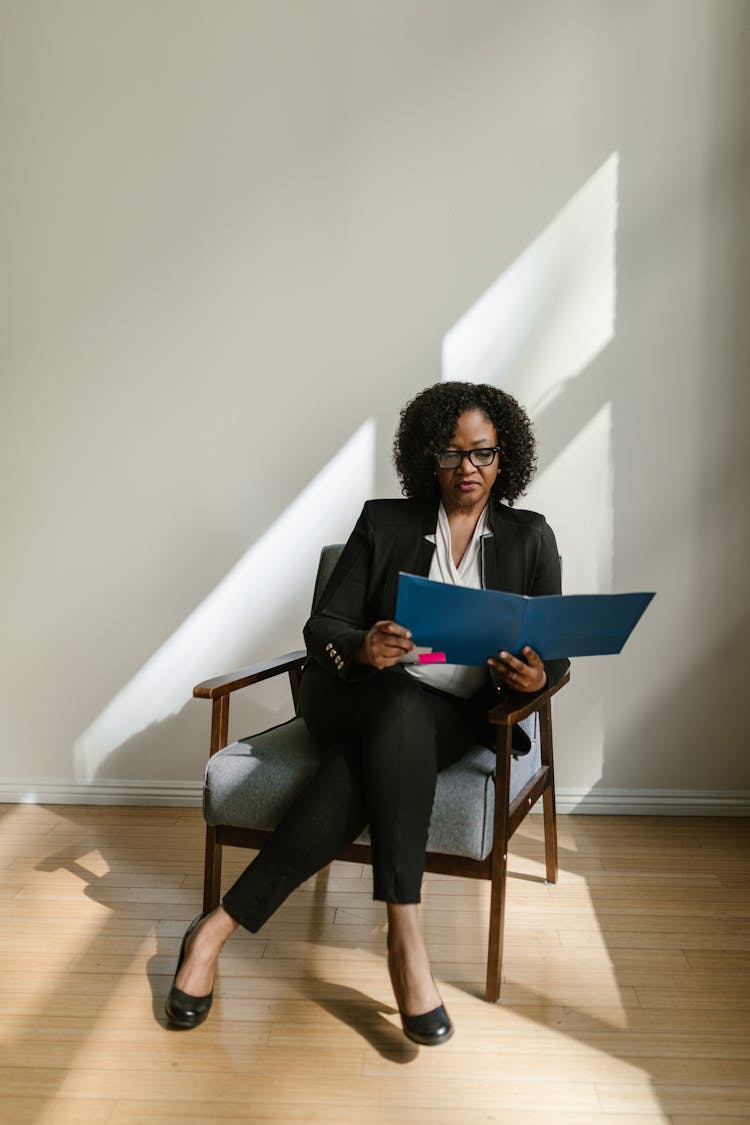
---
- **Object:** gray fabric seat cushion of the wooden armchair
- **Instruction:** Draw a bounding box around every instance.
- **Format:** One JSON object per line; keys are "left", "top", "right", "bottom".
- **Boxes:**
{"left": 204, "top": 716, "right": 540, "bottom": 860}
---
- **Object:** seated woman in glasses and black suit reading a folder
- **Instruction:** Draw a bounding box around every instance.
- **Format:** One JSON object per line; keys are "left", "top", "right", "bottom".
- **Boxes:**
{"left": 166, "top": 383, "right": 568, "bottom": 1045}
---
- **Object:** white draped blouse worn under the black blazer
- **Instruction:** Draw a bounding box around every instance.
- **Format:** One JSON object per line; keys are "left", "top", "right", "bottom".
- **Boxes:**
{"left": 406, "top": 501, "right": 489, "bottom": 699}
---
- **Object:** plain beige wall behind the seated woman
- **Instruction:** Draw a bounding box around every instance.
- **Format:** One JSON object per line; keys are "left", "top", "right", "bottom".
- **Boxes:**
{"left": 0, "top": 0, "right": 750, "bottom": 799}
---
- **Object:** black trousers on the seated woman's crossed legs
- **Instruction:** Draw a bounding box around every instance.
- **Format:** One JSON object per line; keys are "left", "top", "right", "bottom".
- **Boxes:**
{"left": 223, "top": 664, "right": 494, "bottom": 933}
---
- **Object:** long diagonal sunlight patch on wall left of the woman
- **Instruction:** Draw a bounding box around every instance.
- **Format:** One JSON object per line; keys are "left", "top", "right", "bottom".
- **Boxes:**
{"left": 73, "top": 419, "right": 374, "bottom": 781}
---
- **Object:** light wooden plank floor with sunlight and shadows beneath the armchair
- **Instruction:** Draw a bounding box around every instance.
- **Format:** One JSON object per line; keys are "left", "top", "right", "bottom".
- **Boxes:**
{"left": 0, "top": 806, "right": 750, "bottom": 1125}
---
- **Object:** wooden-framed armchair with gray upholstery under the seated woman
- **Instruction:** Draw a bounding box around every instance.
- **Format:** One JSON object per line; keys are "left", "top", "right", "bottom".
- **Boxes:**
{"left": 193, "top": 547, "right": 570, "bottom": 1002}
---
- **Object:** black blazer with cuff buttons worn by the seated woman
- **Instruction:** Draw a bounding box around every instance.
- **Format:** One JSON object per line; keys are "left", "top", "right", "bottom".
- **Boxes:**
{"left": 305, "top": 497, "right": 569, "bottom": 683}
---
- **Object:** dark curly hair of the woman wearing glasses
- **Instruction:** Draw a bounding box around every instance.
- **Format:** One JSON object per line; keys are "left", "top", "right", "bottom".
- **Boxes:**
{"left": 394, "top": 381, "right": 536, "bottom": 505}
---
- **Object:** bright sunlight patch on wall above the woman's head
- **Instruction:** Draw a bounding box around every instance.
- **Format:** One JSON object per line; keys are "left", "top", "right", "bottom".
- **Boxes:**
{"left": 443, "top": 152, "right": 620, "bottom": 414}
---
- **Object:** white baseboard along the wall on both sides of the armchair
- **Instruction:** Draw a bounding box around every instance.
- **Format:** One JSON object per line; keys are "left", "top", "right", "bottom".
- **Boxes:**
{"left": 0, "top": 780, "right": 750, "bottom": 817}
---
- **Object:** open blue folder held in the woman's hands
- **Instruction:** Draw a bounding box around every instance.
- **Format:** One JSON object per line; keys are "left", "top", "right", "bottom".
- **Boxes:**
{"left": 396, "top": 572, "right": 653, "bottom": 665}
